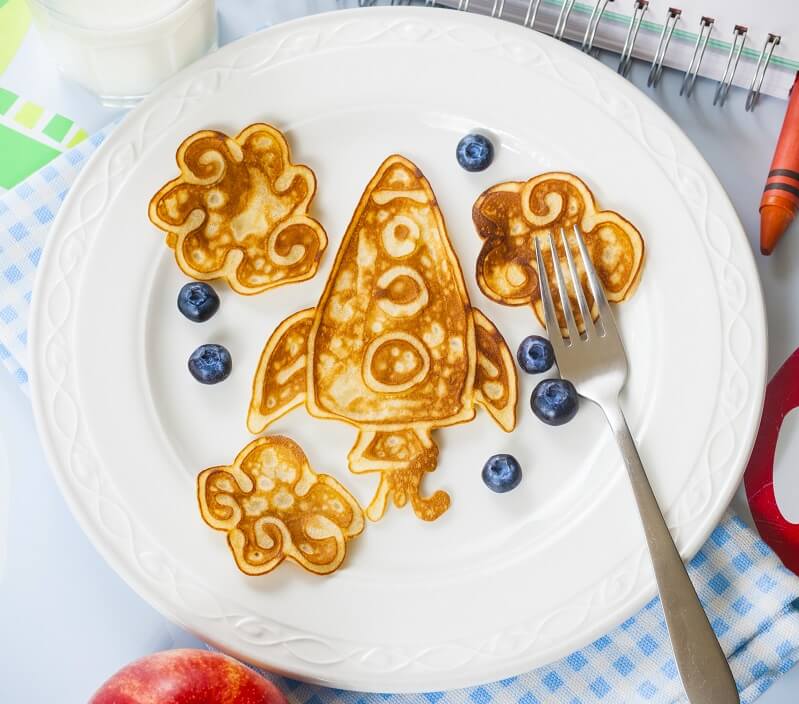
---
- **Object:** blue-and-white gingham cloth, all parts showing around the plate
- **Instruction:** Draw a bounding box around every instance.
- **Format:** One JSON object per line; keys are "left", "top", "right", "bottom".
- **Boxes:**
{"left": 0, "top": 127, "right": 799, "bottom": 704}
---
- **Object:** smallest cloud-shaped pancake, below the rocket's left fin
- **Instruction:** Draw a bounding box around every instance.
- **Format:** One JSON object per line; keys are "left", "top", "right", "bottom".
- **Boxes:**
{"left": 197, "top": 435, "right": 364, "bottom": 575}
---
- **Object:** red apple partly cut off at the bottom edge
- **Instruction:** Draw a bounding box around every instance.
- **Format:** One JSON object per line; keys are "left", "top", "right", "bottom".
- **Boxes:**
{"left": 89, "top": 649, "right": 287, "bottom": 704}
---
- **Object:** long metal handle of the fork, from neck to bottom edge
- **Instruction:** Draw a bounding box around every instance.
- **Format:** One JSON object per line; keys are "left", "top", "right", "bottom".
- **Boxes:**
{"left": 602, "top": 399, "right": 740, "bottom": 704}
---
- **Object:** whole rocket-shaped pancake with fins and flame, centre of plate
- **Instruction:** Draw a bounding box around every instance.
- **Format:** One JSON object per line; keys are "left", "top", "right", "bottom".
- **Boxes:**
{"left": 247, "top": 155, "right": 517, "bottom": 521}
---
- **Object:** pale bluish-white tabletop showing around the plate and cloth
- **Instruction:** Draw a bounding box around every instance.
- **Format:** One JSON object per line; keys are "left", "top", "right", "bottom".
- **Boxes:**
{"left": 0, "top": 0, "right": 799, "bottom": 704}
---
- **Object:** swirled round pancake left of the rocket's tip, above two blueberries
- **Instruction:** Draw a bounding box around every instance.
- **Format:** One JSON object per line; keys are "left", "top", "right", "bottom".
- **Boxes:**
{"left": 149, "top": 124, "right": 327, "bottom": 294}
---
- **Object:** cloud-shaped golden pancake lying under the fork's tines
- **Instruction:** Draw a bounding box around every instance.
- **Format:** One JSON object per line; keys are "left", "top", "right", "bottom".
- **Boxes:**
{"left": 472, "top": 173, "right": 644, "bottom": 334}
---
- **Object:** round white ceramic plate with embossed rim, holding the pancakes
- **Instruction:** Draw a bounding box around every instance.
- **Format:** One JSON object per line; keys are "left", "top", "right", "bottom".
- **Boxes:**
{"left": 31, "top": 8, "right": 766, "bottom": 691}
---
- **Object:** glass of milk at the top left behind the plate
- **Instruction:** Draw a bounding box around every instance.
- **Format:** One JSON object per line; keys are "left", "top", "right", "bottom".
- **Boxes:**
{"left": 28, "top": 0, "right": 217, "bottom": 107}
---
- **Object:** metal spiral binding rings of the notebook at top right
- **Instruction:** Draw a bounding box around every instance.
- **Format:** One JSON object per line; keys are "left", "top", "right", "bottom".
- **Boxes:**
{"left": 378, "top": 0, "right": 780, "bottom": 112}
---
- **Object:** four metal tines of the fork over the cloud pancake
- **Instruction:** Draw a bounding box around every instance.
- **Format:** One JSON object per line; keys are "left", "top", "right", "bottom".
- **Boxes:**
{"left": 535, "top": 224, "right": 615, "bottom": 345}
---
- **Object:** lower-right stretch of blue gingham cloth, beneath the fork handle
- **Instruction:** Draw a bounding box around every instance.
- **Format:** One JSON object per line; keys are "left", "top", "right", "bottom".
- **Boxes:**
{"left": 256, "top": 513, "right": 799, "bottom": 704}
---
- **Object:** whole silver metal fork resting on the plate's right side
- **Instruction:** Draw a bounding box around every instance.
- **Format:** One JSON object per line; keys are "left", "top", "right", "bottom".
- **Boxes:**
{"left": 535, "top": 225, "right": 739, "bottom": 704}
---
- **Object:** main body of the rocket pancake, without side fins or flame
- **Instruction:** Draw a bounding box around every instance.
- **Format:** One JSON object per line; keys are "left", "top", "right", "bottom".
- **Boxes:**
{"left": 308, "top": 154, "right": 476, "bottom": 427}
